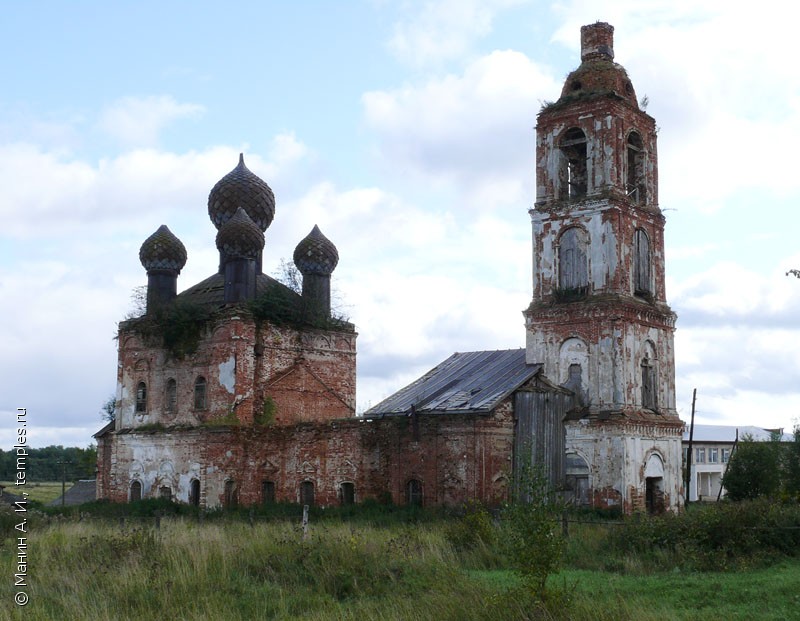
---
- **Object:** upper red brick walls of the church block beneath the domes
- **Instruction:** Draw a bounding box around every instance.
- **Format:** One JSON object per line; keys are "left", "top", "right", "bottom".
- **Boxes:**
{"left": 116, "top": 309, "right": 356, "bottom": 430}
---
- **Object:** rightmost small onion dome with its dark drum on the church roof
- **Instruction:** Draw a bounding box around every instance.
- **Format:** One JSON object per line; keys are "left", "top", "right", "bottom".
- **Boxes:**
{"left": 293, "top": 224, "right": 339, "bottom": 319}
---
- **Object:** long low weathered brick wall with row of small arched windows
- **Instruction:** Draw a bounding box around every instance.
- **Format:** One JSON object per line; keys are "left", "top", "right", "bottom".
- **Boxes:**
{"left": 105, "top": 400, "right": 513, "bottom": 507}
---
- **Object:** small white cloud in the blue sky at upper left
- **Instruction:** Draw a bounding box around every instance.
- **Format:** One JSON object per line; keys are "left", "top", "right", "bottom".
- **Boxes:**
{"left": 97, "top": 95, "right": 205, "bottom": 147}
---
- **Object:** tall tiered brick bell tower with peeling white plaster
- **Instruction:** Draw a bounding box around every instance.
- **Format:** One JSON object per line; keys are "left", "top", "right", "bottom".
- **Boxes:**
{"left": 524, "top": 22, "right": 682, "bottom": 510}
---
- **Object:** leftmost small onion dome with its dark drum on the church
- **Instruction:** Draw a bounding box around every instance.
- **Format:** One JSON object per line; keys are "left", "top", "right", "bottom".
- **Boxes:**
{"left": 139, "top": 224, "right": 186, "bottom": 313}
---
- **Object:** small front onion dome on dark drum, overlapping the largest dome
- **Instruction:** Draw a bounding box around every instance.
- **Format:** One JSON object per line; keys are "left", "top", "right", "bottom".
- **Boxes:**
{"left": 217, "top": 207, "right": 264, "bottom": 304}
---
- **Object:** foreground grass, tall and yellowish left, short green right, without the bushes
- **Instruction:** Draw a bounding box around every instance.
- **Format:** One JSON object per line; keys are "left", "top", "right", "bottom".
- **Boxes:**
{"left": 0, "top": 518, "right": 800, "bottom": 621}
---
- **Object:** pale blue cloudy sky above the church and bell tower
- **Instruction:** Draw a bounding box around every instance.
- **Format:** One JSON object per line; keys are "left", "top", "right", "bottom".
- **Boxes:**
{"left": 0, "top": 0, "right": 800, "bottom": 449}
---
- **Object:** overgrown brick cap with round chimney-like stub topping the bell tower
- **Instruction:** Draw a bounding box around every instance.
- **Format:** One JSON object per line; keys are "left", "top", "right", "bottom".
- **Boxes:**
{"left": 559, "top": 22, "right": 639, "bottom": 110}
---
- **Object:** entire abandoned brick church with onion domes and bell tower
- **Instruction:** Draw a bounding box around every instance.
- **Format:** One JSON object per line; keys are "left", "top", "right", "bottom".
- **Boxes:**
{"left": 96, "top": 22, "right": 683, "bottom": 512}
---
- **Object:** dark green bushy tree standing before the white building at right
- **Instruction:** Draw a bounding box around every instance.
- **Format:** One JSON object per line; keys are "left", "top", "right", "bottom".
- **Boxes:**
{"left": 722, "top": 435, "right": 783, "bottom": 500}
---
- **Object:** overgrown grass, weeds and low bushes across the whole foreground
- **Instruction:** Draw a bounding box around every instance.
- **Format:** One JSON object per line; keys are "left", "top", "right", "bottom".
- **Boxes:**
{"left": 0, "top": 501, "right": 800, "bottom": 621}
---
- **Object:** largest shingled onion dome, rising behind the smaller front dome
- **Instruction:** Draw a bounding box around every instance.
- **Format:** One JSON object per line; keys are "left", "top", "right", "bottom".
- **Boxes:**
{"left": 208, "top": 153, "right": 275, "bottom": 231}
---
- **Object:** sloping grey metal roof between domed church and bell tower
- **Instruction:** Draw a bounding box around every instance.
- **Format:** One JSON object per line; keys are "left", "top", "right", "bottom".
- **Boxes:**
{"left": 364, "top": 349, "right": 542, "bottom": 416}
